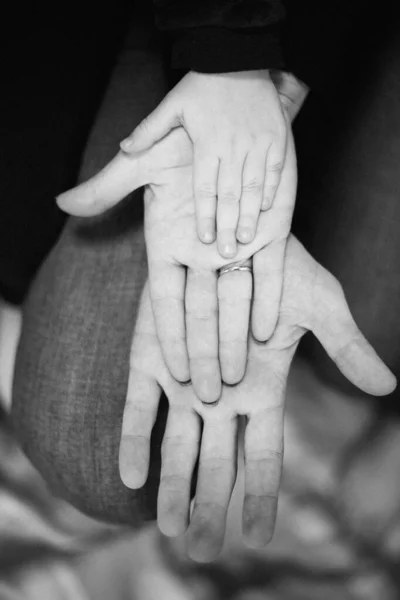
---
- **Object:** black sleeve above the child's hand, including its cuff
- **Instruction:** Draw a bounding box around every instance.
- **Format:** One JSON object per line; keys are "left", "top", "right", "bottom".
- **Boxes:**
{"left": 149, "top": 0, "right": 285, "bottom": 73}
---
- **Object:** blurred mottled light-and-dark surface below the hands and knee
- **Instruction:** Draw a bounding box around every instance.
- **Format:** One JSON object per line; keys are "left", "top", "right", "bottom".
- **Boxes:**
{"left": 0, "top": 305, "right": 400, "bottom": 600}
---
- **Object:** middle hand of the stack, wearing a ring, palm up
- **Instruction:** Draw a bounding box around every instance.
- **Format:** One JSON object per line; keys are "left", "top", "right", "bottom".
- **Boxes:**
{"left": 58, "top": 128, "right": 296, "bottom": 402}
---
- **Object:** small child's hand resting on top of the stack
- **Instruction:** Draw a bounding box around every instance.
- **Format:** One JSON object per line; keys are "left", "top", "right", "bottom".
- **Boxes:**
{"left": 121, "top": 71, "right": 287, "bottom": 258}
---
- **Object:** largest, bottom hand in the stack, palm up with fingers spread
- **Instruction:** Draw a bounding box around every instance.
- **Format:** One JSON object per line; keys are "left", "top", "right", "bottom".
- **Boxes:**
{"left": 120, "top": 237, "right": 396, "bottom": 560}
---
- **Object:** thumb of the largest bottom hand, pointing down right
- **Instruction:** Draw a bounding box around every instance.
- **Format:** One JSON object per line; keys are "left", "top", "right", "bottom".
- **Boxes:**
{"left": 311, "top": 272, "right": 396, "bottom": 396}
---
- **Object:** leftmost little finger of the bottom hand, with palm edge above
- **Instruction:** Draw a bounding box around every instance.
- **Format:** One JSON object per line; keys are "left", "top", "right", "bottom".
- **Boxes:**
{"left": 119, "top": 287, "right": 163, "bottom": 489}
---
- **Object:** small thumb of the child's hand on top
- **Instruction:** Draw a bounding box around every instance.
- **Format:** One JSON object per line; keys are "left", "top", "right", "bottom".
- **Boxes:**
{"left": 120, "top": 96, "right": 182, "bottom": 153}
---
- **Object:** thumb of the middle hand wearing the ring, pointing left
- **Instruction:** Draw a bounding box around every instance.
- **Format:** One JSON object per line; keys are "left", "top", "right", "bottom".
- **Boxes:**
{"left": 57, "top": 153, "right": 141, "bottom": 217}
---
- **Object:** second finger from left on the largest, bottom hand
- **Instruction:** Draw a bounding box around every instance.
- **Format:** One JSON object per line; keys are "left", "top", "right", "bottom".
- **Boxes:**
{"left": 157, "top": 406, "right": 201, "bottom": 537}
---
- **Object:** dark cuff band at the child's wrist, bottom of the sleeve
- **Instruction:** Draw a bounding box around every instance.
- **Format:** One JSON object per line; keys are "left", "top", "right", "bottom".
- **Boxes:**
{"left": 172, "top": 27, "right": 284, "bottom": 73}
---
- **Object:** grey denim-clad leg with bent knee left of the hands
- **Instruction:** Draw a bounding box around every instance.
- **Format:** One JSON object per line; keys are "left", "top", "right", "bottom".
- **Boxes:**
{"left": 13, "top": 19, "right": 167, "bottom": 525}
